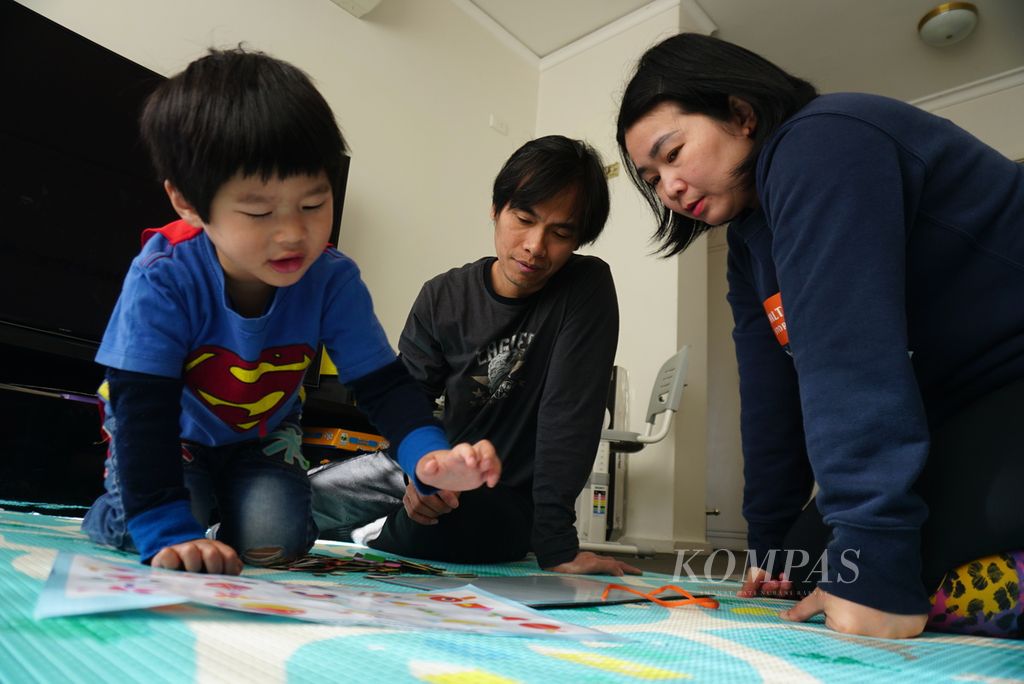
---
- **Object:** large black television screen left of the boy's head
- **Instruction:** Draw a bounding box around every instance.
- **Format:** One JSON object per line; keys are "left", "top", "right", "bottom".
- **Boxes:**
{"left": 0, "top": 0, "right": 174, "bottom": 356}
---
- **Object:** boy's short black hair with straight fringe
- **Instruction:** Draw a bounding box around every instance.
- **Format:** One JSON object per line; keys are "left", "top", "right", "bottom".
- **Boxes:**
{"left": 139, "top": 46, "right": 347, "bottom": 225}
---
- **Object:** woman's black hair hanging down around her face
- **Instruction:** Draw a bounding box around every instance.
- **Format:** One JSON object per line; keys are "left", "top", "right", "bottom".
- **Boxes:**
{"left": 615, "top": 33, "right": 818, "bottom": 256}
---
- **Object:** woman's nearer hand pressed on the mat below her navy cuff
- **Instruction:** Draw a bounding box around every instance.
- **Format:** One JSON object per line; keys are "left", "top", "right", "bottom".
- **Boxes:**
{"left": 779, "top": 588, "right": 928, "bottom": 639}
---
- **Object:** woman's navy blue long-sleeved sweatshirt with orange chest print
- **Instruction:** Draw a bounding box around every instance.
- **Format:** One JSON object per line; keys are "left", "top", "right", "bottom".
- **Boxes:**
{"left": 728, "top": 93, "right": 1024, "bottom": 613}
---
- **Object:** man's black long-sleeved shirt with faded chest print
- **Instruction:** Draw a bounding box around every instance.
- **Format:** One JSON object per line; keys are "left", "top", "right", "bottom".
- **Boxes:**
{"left": 398, "top": 255, "right": 618, "bottom": 567}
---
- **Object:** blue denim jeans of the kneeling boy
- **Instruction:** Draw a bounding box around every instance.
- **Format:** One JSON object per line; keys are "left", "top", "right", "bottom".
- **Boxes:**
{"left": 82, "top": 412, "right": 317, "bottom": 565}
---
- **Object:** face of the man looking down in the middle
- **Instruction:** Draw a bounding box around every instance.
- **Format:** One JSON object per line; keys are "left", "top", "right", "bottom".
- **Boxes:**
{"left": 490, "top": 188, "right": 580, "bottom": 298}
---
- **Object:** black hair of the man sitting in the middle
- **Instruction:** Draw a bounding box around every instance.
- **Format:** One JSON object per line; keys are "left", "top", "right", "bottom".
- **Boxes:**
{"left": 492, "top": 135, "right": 608, "bottom": 247}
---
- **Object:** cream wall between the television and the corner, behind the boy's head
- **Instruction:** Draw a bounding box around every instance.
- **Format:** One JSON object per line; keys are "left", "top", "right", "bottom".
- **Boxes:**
{"left": 19, "top": 0, "right": 539, "bottom": 343}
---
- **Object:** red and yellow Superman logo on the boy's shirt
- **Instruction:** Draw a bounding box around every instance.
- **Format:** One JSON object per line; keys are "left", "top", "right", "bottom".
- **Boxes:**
{"left": 184, "top": 344, "right": 314, "bottom": 434}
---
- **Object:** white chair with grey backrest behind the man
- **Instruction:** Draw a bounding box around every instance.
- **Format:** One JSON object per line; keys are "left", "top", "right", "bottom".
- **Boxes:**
{"left": 580, "top": 346, "right": 689, "bottom": 555}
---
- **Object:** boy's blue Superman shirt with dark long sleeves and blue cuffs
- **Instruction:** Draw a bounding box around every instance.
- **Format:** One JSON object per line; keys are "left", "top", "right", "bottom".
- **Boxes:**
{"left": 96, "top": 221, "right": 449, "bottom": 561}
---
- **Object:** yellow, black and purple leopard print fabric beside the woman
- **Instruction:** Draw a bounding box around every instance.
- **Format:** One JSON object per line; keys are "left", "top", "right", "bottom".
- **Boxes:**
{"left": 926, "top": 551, "right": 1024, "bottom": 639}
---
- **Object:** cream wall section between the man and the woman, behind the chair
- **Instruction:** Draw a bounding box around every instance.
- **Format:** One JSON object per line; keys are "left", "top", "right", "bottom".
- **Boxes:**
{"left": 537, "top": 5, "right": 707, "bottom": 548}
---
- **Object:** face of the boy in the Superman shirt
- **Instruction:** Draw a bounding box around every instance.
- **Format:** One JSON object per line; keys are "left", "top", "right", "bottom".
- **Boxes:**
{"left": 172, "top": 172, "right": 334, "bottom": 304}
